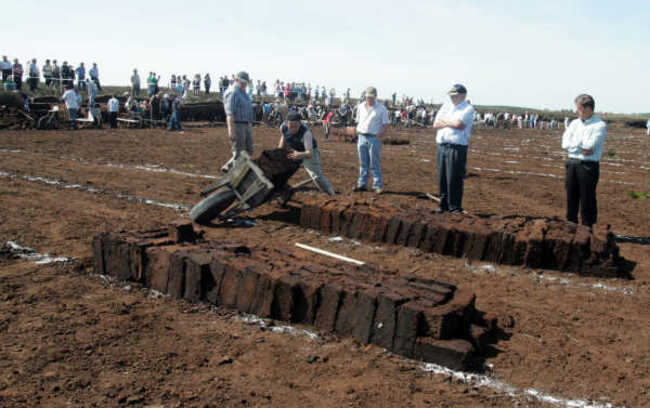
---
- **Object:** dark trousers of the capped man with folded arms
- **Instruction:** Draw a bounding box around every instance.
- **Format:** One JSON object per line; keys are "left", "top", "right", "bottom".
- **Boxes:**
{"left": 438, "top": 143, "right": 467, "bottom": 211}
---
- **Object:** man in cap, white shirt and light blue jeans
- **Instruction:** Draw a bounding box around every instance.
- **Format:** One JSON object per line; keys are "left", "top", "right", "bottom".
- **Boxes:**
{"left": 353, "top": 86, "right": 390, "bottom": 194}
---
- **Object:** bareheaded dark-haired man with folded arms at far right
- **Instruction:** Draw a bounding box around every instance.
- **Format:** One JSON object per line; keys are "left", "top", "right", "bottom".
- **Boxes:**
{"left": 562, "top": 94, "right": 607, "bottom": 227}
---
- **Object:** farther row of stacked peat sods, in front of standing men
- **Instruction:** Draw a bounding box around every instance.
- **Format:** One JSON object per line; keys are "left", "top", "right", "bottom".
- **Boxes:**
{"left": 297, "top": 197, "right": 625, "bottom": 277}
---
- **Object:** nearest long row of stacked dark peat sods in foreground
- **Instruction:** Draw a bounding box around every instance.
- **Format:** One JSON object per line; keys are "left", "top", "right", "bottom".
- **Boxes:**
{"left": 93, "top": 224, "right": 498, "bottom": 369}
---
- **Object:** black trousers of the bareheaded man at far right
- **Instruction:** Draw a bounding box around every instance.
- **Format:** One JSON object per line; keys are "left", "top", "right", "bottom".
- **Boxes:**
{"left": 566, "top": 159, "right": 600, "bottom": 227}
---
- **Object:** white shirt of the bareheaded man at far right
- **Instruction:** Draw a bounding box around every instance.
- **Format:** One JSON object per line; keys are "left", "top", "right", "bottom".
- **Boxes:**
{"left": 562, "top": 116, "right": 607, "bottom": 162}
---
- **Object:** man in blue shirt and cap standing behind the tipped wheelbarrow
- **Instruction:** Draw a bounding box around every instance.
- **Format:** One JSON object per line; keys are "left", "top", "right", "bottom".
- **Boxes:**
{"left": 221, "top": 71, "right": 255, "bottom": 172}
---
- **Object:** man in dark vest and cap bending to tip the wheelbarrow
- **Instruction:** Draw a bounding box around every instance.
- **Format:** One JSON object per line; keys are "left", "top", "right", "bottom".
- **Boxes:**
{"left": 278, "top": 112, "right": 336, "bottom": 195}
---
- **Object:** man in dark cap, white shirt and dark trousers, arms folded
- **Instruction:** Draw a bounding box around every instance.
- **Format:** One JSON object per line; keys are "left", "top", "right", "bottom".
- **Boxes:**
{"left": 433, "top": 84, "right": 474, "bottom": 212}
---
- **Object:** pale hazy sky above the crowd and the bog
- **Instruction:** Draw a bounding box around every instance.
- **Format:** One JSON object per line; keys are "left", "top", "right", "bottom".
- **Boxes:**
{"left": 5, "top": 0, "right": 650, "bottom": 113}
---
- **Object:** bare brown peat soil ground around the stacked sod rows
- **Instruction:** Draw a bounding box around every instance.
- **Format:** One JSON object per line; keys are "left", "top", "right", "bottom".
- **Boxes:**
{"left": 0, "top": 122, "right": 650, "bottom": 407}
